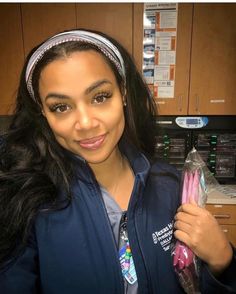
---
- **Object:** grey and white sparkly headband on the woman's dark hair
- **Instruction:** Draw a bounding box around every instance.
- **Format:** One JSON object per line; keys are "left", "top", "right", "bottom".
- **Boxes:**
{"left": 25, "top": 30, "right": 125, "bottom": 100}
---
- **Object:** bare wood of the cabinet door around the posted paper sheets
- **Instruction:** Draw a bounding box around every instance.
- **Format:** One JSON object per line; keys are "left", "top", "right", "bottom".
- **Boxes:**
{"left": 134, "top": 3, "right": 193, "bottom": 115}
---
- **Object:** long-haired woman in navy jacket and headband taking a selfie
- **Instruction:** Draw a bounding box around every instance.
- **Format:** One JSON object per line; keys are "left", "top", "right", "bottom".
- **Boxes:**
{"left": 0, "top": 30, "right": 236, "bottom": 294}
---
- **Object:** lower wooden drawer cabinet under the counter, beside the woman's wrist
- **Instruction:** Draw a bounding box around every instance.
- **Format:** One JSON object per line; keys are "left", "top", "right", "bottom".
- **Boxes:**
{"left": 206, "top": 204, "right": 236, "bottom": 246}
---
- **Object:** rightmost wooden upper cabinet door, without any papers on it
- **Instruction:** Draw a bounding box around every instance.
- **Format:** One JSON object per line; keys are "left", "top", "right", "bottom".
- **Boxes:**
{"left": 189, "top": 3, "right": 236, "bottom": 115}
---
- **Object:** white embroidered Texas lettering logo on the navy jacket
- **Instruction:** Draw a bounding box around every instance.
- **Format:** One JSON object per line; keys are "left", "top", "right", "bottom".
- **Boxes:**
{"left": 152, "top": 223, "right": 173, "bottom": 251}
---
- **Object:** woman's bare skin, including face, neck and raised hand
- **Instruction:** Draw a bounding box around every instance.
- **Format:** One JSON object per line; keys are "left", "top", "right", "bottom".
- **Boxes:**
{"left": 39, "top": 50, "right": 232, "bottom": 275}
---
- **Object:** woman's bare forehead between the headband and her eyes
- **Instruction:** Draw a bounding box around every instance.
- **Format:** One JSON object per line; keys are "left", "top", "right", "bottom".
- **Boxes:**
{"left": 39, "top": 50, "right": 118, "bottom": 97}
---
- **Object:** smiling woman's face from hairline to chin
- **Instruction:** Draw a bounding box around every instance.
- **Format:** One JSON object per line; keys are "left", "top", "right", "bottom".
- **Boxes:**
{"left": 39, "top": 50, "right": 125, "bottom": 164}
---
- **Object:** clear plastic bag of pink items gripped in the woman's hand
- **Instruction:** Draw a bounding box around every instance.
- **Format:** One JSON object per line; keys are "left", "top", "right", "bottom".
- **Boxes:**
{"left": 171, "top": 148, "right": 219, "bottom": 294}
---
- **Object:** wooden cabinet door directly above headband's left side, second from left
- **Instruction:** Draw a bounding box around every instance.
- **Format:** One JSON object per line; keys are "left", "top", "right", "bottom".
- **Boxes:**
{"left": 21, "top": 3, "right": 76, "bottom": 54}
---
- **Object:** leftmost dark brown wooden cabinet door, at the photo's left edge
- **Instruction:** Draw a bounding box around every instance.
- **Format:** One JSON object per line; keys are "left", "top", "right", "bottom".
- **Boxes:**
{"left": 0, "top": 3, "right": 24, "bottom": 115}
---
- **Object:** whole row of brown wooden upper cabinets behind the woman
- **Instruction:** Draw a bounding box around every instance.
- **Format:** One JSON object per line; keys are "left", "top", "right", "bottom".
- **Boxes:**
{"left": 0, "top": 3, "right": 236, "bottom": 115}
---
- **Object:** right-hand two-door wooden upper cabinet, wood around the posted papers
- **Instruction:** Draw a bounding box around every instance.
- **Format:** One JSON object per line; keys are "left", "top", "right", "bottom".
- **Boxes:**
{"left": 134, "top": 3, "right": 236, "bottom": 115}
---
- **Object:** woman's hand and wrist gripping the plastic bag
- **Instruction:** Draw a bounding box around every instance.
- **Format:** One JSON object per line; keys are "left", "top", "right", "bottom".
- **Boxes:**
{"left": 174, "top": 202, "right": 233, "bottom": 275}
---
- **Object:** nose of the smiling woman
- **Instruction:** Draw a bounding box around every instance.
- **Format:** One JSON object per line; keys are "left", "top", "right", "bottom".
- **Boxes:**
{"left": 75, "top": 106, "right": 98, "bottom": 130}
